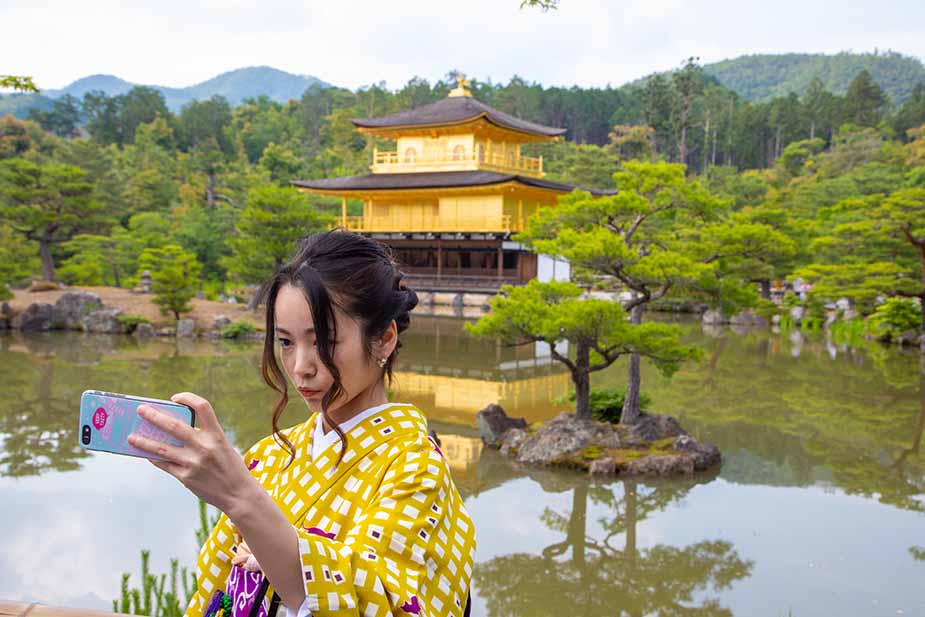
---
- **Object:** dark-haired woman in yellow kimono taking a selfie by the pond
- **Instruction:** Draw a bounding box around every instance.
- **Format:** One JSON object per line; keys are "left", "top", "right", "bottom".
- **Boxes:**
{"left": 130, "top": 231, "right": 475, "bottom": 617}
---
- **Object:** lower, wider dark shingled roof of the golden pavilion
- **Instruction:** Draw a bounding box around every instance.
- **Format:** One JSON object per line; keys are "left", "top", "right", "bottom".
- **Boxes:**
{"left": 292, "top": 171, "right": 616, "bottom": 196}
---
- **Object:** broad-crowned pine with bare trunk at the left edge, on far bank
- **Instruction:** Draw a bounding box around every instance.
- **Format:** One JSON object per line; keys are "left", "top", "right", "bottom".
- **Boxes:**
{"left": 0, "top": 159, "right": 105, "bottom": 281}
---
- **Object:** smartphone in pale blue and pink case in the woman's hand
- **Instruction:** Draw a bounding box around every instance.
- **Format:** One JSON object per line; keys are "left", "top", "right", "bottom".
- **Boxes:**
{"left": 79, "top": 390, "right": 196, "bottom": 460}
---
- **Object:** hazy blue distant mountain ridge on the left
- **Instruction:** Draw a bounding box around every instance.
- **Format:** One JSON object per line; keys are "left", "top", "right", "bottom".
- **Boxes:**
{"left": 42, "top": 66, "right": 331, "bottom": 111}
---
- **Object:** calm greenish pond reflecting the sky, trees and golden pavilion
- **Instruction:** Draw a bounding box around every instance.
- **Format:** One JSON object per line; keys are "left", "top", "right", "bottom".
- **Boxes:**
{"left": 0, "top": 317, "right": 925, "bottom": 617}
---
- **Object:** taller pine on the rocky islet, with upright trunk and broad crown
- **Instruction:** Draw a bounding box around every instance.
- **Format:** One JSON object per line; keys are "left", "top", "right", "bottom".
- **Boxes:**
{"left": 519, "top": 161, "right": 772, "bottom": 424}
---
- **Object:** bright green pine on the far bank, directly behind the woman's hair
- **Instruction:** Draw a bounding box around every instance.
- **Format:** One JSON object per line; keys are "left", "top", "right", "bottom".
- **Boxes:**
{"left": 227, "top": 186, "right": 332, "bottom": 290}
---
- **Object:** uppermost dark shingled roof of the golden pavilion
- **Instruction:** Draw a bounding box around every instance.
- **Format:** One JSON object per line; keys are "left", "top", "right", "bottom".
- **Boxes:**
{"left": 352, "top": 96, "right": 566, "bottom": 137}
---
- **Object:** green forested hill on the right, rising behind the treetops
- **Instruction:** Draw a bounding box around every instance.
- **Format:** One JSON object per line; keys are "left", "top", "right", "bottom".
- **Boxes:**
{"left": 703, "top": 52, "right": 925, "bottom": 105}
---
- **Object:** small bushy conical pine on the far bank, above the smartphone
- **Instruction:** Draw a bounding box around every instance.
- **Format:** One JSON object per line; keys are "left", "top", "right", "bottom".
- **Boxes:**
{"left": 138, "top": 244, "right": 202, "bottom": 319}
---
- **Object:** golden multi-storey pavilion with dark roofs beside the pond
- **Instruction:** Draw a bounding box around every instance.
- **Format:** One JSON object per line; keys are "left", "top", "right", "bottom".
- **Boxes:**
{"left": 293, "top": 77, "right": 605, "bottom": 291}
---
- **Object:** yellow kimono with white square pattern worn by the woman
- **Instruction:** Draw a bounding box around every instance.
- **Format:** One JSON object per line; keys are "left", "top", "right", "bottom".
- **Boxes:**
{"left": 186, "top": 404, "right": 475, "bottom": 617}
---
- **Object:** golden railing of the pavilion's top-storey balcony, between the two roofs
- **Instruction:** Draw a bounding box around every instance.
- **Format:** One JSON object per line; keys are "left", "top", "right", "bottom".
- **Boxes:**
{"left": 372, "top": 145, "right": 545, "bottom": 177}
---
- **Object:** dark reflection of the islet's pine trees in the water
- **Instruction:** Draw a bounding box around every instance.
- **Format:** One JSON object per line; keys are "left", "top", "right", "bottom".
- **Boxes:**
{"left": 475, "top": 478, "right": 753, "bottom": 617}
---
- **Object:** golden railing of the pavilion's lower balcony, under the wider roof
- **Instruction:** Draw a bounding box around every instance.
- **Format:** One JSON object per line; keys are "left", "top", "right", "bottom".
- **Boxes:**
{"left": 338, "top": 213, "right": 519, "bottom": 233}
